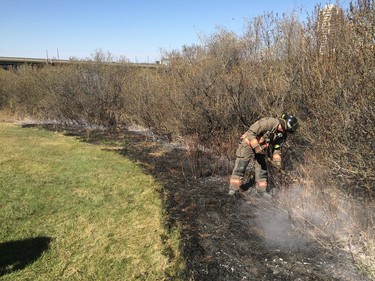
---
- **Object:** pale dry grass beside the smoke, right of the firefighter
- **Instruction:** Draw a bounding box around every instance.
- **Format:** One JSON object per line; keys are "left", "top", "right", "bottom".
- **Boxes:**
{"left": 279, "top": 173, "right": 375, "bottom": 280}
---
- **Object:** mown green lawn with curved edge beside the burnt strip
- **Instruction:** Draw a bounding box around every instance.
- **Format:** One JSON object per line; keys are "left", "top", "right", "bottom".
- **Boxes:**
{"left": 0, "top": 123, "right": 183, "bottom": 280}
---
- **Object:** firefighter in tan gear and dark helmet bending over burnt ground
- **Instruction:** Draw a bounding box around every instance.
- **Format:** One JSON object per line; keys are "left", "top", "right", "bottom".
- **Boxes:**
{"left": 229, "top": 114, "right": 298, "bottom": 195}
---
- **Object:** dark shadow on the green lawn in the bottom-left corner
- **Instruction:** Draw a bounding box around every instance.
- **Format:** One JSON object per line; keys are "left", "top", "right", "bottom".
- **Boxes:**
{"left": 0, "top": 237, "right": 52, "bottom": 277}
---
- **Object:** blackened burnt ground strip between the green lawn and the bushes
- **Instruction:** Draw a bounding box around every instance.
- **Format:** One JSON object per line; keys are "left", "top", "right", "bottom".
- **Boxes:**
{"left": 31, "top": 124, "right": 369, "bottom": 281}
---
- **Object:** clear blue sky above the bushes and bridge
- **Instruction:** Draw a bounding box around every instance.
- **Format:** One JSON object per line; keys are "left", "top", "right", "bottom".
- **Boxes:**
{"left": 0, "top": 0, "right": 350, "bottom": 63}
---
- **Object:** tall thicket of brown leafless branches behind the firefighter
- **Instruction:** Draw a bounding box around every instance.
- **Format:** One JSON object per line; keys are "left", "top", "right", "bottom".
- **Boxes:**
{"left": 0, "top": 0, "right": 375, "bottom": 276}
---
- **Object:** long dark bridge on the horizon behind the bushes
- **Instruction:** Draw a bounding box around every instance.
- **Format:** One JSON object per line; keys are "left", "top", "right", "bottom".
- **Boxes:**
{"left": 0, "top": 57, "right": 160, "bottom": 69}
